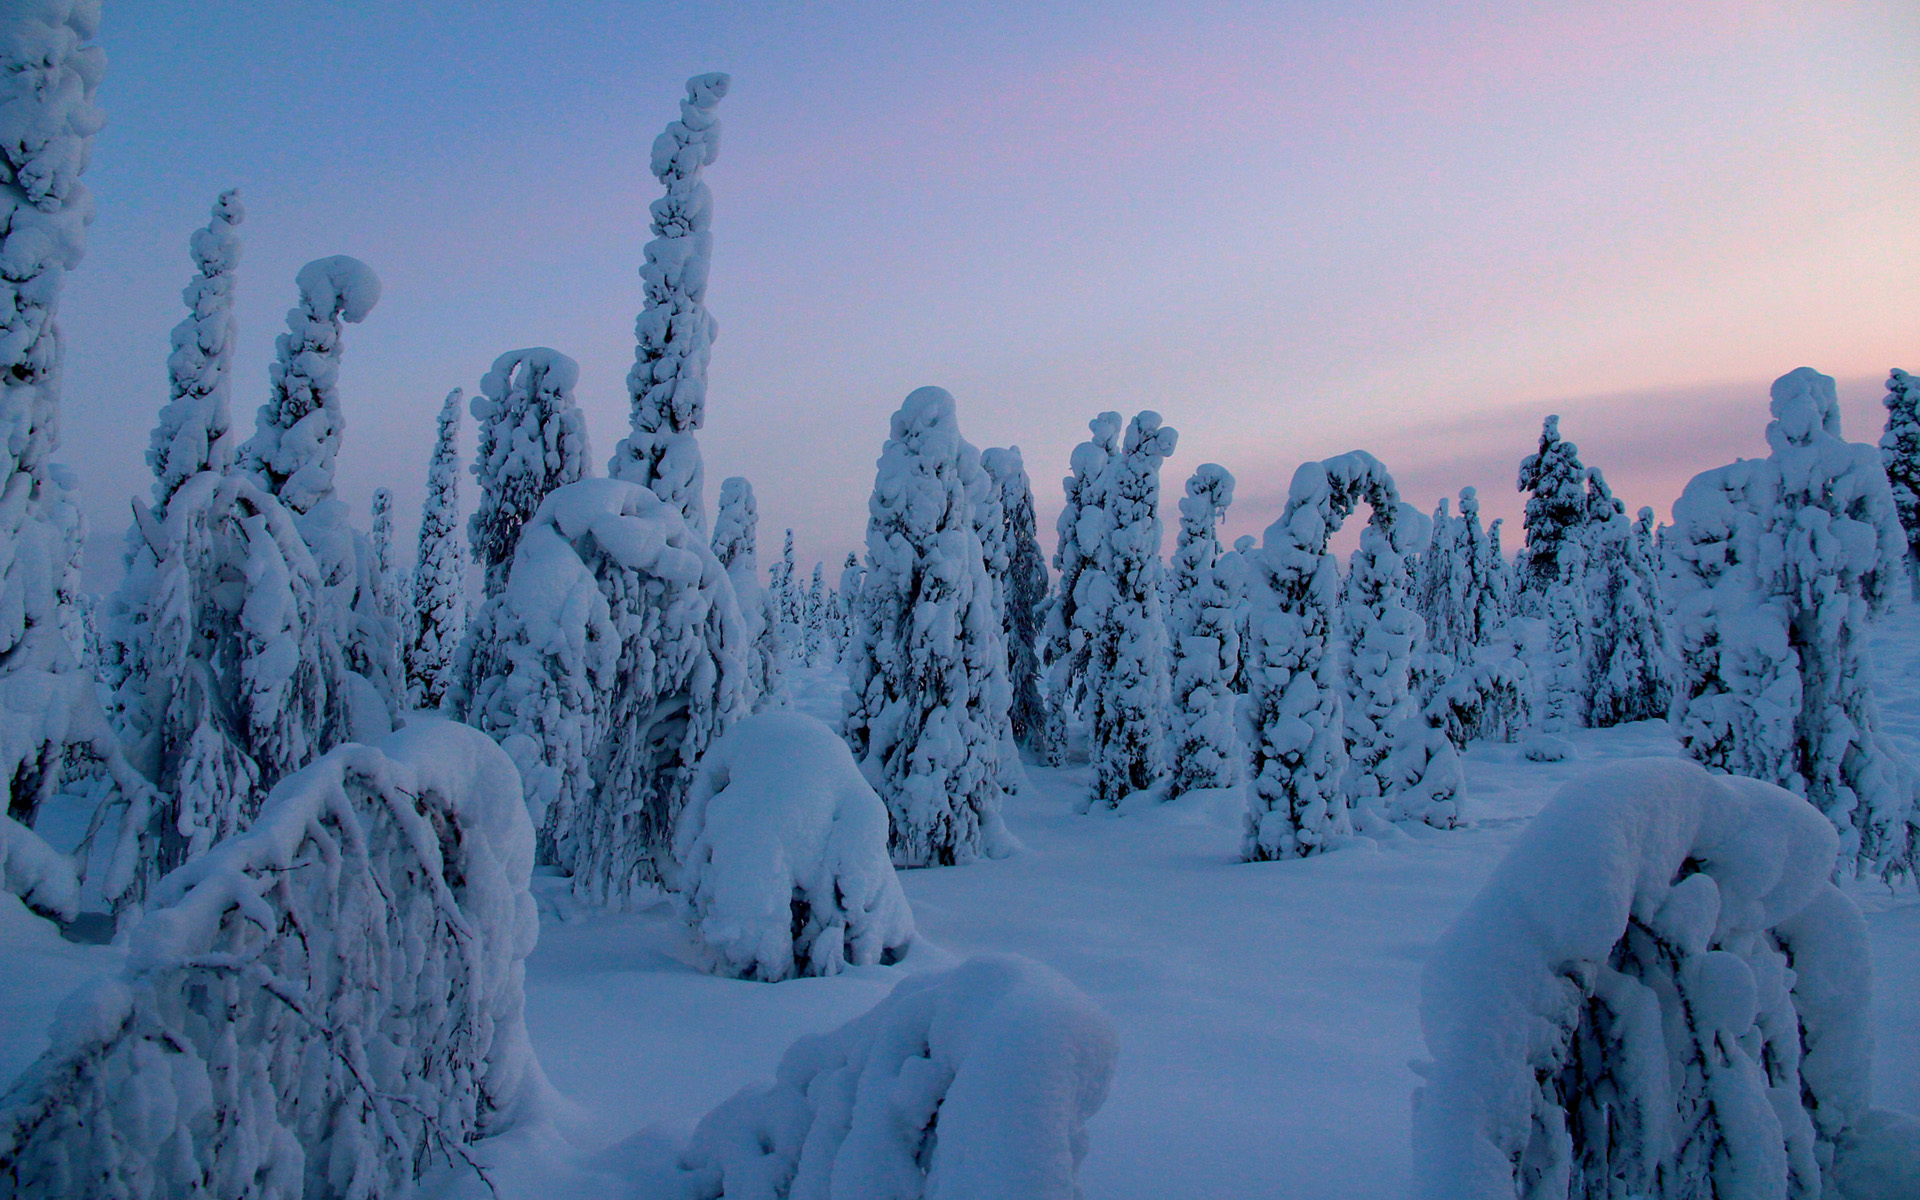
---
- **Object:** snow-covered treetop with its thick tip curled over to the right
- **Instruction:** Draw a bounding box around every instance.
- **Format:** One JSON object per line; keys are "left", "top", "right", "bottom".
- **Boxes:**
{"left": 240, "top": 253, "right": 380, "bottom": 513}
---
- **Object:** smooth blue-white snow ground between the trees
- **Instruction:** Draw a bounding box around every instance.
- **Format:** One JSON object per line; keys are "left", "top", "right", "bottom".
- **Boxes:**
{"left": 11, "top": 633, "right": 1920, "bottom": 1200}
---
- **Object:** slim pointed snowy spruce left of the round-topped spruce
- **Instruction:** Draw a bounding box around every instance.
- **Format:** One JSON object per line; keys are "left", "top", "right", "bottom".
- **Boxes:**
{"left": 407, "top": 388, "right": 467, "bottom": 708}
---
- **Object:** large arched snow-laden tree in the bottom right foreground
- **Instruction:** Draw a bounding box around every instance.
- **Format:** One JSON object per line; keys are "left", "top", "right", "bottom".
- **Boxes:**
{"left": 1413, "top": 758, "right": 1891, "bottom": 1200}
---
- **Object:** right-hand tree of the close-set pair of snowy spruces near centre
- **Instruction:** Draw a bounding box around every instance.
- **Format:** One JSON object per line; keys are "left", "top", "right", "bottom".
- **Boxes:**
{"left": 1073, "top": 411, "right": 1179, "bottom": 806}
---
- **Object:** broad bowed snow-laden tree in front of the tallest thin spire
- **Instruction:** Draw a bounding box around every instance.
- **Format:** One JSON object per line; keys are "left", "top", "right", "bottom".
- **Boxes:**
{"left": 451, "top": 480, "right": 749, "bottom": 902}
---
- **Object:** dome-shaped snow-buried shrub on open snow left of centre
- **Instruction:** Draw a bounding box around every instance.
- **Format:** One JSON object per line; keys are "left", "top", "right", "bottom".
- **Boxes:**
{"left": 672, "top": 712, "right": 914, "bottom": 983}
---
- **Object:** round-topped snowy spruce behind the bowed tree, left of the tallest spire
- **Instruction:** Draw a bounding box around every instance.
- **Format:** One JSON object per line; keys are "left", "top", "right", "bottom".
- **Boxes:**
{"left": 467, "top": 346, "right": 588, "bottom": 599}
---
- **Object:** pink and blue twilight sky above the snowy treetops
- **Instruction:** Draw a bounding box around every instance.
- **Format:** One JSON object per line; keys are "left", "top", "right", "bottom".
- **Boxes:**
{"left": 61, "top": 0, "right": 1920, "bottom": 589}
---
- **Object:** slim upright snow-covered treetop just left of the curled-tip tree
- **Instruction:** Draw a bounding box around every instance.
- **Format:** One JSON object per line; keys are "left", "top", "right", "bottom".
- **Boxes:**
{"left": 146, "top": 190, "right": 246, "bottom": 509}
